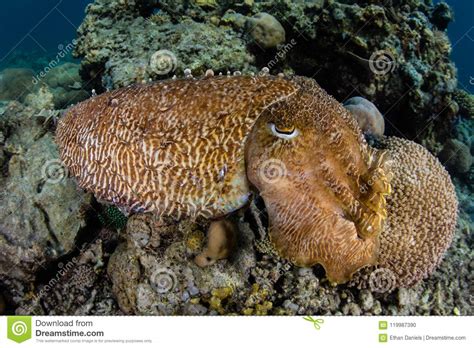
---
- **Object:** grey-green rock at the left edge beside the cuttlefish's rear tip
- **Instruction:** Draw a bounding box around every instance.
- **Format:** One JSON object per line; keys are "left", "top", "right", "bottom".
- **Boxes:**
{"left": 0, "top": 102, "right": 92, "bottom": 296}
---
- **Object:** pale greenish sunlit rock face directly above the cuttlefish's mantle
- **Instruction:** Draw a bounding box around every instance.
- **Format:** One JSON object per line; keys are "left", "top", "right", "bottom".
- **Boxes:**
{"left": 75, "top": 0, "right": 257, "bottom": 90}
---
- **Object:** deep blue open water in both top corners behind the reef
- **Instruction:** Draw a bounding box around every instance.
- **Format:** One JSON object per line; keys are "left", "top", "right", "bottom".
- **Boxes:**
{"left": 0, "top": 0, "right": 474, "bottom": 93}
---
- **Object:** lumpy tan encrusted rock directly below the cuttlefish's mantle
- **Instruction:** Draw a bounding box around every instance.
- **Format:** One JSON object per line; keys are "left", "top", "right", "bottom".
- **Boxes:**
{"left": 108, "top": 215, "right": 256, "bottom": 315}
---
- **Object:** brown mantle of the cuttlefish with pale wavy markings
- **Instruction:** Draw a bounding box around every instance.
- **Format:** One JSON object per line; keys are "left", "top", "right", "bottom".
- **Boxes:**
{"left": 57, "top": 77, "right": 296, "bottom": 220}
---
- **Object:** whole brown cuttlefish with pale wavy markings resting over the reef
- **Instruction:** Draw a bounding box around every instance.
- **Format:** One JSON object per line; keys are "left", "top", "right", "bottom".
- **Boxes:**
{"left": 56, "top": 75, "right": 460, "bottom": 283}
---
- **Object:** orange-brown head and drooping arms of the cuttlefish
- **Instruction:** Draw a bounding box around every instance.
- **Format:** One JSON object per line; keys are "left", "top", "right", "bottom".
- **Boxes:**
{"left": 246, "top": 78, "right": 390, "bottom": 283}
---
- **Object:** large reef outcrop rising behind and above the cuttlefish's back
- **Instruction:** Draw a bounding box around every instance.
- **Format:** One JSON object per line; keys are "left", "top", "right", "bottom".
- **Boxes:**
{"left": 75, "top": 0, "right": 457, "bottom": 147}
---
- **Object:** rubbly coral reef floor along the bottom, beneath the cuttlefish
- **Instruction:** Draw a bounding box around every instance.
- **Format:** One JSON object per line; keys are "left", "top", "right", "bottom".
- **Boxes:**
{"left": 0, "top": 106, "right": 474, "bottom": 315}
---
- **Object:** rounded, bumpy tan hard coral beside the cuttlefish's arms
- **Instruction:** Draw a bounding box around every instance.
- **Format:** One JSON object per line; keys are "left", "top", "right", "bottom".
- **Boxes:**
{"left": 377, "top": 137, "right": 458, "bottom": 287}
